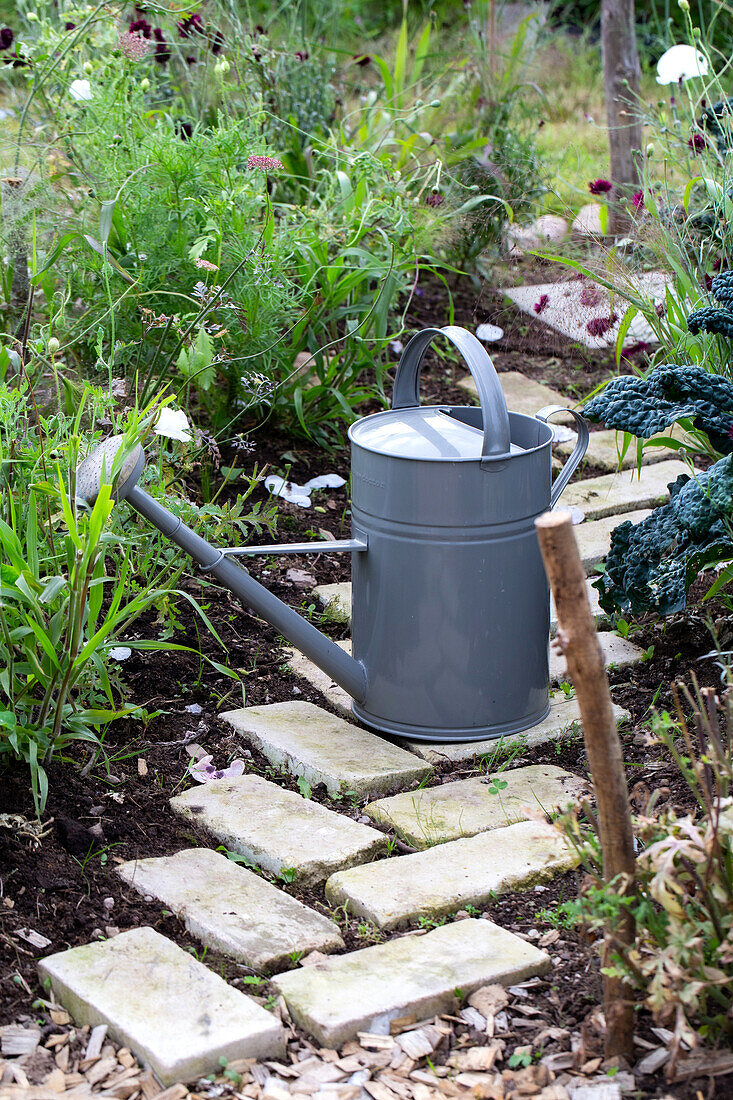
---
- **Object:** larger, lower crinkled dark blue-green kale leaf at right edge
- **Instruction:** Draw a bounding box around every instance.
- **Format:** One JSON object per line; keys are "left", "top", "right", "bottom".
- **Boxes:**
{"left": 594, "top": 454, "right": 733, "bottom": 615}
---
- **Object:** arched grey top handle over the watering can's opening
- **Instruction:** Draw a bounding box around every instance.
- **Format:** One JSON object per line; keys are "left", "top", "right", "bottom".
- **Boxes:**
{"left": 392, "top": 325, "right": 511, "bottom": 458}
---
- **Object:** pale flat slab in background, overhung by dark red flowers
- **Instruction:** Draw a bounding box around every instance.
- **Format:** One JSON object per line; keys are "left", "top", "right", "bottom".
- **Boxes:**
{"left": 504, "top": 272, "right": 668, "bottom": 348}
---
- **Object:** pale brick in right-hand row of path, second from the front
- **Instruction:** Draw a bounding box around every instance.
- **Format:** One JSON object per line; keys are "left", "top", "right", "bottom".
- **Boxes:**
{"left": 326, "top": 821, "right": 577, "bottom": 930}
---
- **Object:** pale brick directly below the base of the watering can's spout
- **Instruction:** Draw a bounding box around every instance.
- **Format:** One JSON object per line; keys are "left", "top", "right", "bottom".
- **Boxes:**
{"left": 221, "top": 702, "right": 431, "bottom": 795}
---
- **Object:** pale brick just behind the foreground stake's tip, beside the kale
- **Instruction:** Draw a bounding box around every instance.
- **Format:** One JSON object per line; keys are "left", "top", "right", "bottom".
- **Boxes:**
{"left": 558, "top": 461, "right": 689, "bottom": 523}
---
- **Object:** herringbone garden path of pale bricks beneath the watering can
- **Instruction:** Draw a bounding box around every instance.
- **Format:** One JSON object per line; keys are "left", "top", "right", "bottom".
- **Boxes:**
{"left": 32, "top": 367, "right": 683, "bottom": 1088}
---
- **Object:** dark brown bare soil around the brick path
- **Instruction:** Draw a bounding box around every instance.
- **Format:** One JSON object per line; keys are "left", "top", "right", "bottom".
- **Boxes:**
{"left": 0, "top": 271, "right": 733, "bottom": 1098}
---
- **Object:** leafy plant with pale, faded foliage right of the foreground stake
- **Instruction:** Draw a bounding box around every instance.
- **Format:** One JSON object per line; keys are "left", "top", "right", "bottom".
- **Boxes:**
{"left": 558, "top": 669, "right": 733, "bottom": 1043}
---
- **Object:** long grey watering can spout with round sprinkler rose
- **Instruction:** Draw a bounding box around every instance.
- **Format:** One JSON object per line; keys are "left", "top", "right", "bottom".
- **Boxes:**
{"left": 77, "top": 436, "right": 367, "bottom": 703}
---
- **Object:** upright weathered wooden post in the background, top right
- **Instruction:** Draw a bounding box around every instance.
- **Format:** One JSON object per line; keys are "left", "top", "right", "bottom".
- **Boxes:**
{"left": 601, "top": 0, "right": 642, "bottom": 233}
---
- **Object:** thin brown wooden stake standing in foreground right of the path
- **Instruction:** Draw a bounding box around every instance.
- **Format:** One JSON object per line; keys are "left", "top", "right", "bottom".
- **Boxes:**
{"left": 535, "top": 512, "right": 635, "bottom": 1062}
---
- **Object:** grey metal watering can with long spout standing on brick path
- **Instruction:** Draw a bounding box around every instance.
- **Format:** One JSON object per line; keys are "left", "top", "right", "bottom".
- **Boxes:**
{"left": 77, "top": 326, "right": 588, "bottom": 741}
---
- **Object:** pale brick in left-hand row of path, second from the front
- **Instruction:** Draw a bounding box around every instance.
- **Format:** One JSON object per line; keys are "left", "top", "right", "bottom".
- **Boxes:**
{"left": 117, "top": 848, "right": 343, "bottom": 971}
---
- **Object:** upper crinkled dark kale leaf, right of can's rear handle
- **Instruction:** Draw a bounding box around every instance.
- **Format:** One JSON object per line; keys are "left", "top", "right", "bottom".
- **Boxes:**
{"left": 583, "top": 365, "right": 733, "bottom": 454}
